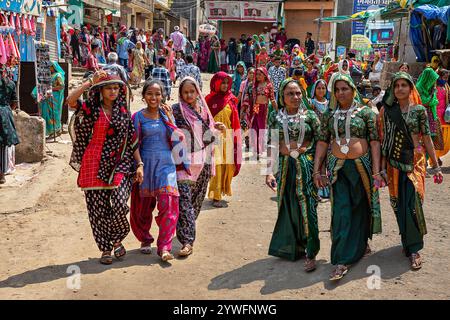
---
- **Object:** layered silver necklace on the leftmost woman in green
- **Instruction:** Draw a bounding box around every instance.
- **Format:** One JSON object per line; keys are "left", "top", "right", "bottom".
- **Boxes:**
{"left": 277, "top": 104, "right": 306, "bottom": 159}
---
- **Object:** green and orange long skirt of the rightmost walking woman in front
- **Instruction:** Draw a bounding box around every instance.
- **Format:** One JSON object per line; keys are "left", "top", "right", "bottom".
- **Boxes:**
{"left": 387, "top": 147, "right": 427, "bottom": 256}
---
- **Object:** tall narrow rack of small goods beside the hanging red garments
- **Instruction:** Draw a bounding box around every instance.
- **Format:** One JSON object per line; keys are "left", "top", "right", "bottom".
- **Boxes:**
{"left": 34, "top": 41, "right": 52, "bottom": 103}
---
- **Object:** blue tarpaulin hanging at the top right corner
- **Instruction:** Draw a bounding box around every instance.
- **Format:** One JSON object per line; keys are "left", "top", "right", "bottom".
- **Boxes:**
{"left": 409, "top": 5, "right": 450, "bottom": 62}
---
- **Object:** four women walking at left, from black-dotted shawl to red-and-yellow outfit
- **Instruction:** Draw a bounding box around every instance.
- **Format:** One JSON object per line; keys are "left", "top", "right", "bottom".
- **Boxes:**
{"left": 68, "top": 70, "right": 241, "bottom": 264}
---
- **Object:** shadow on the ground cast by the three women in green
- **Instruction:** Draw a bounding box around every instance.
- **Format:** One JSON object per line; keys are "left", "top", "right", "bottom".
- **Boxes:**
{"left": 208, "top": 246, "right": 410, "bottom": 295}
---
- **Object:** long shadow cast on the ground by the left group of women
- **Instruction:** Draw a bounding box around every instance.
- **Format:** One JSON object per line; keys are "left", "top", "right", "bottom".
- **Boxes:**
{"left": 0, "top": 241, "right": 181, "bottom": 288}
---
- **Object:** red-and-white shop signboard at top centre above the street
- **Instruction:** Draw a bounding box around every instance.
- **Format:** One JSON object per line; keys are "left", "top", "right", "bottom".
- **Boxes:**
{"left": 205, "top": 1, "right": 278, "bottom": 22}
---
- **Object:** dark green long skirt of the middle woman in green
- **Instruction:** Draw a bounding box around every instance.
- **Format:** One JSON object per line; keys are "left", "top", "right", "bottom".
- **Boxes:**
{"left": 329, "top": 154, "right": 381, "bottom": 265}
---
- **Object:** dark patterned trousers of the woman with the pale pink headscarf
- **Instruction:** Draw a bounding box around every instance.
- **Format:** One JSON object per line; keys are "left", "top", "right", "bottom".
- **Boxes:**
{"left": 177, "top": 164, "right": 211, "bottom": 246}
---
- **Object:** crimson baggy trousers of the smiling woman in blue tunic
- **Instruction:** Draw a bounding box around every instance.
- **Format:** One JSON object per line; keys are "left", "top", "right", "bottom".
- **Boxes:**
{"left": 130, "top": 183, "right": 179, "bottom": 255}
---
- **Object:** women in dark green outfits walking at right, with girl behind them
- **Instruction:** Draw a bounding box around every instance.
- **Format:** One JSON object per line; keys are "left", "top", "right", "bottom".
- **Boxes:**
{"left": 266, "top": 72, "right": 443, "bottom": 280}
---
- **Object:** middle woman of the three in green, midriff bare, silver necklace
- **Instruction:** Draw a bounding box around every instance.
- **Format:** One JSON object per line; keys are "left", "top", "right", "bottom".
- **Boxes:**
{"left": 313, "top": 74, "right": 384, "bottom": 280}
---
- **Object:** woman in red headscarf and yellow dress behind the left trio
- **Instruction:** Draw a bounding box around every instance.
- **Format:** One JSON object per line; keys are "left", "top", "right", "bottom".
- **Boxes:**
{"left": 205, "top": 72, "right": 242, "bottom": 208}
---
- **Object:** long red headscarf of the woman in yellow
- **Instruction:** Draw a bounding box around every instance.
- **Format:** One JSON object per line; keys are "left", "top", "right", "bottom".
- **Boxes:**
{"left": 205, "top": 71, "right": 242, "bottom": 176}
